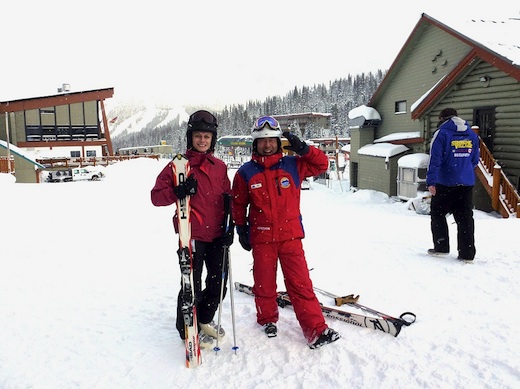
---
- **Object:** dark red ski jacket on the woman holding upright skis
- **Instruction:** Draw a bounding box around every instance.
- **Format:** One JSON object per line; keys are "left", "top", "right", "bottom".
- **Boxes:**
{"left": 151, "top": 150, "right": 231, "bottom": 242}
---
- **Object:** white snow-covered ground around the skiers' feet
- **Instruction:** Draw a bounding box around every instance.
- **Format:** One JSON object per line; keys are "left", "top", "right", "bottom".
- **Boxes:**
{"left": 0, "top": 159, "right": 520, "bottom": 389}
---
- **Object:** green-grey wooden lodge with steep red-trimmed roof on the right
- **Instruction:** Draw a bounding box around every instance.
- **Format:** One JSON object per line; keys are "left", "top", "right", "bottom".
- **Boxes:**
{"left": 349, "top": 14, "right": 520, "bottom": 217}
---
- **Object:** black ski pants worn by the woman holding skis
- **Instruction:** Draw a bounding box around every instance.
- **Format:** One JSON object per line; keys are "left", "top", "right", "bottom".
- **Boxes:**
{"left": 176, "top": 238, "right": 228, "bottom": 339}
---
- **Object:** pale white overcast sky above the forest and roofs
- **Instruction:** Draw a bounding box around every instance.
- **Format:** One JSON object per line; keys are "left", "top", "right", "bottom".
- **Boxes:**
{"left": 0, "top": 0, "right": 520, "bottom": 106}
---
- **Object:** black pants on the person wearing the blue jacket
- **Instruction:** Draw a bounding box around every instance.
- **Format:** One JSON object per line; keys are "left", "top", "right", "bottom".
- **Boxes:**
{"left": 430, "top": 185, "right": 476, "bottom": 259}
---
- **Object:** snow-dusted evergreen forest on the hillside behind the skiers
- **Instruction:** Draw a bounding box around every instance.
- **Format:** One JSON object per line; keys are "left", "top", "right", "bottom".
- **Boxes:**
{"left": 112, "top": 70, "right": 385, "bottom": 150}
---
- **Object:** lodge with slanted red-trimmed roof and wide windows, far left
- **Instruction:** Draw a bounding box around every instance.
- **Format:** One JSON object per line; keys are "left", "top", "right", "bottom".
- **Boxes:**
{"left": 0, "top": 88, "right": 114, "bottom": 182}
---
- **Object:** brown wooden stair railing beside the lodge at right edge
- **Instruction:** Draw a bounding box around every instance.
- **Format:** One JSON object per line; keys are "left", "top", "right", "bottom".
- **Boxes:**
{"left": 477, "top": 137, "right": 520, "bottom": 217}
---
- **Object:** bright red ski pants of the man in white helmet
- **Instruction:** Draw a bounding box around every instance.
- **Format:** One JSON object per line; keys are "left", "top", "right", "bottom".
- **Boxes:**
{"left": 253, "top": 239, "right": 327, "bottom": 342}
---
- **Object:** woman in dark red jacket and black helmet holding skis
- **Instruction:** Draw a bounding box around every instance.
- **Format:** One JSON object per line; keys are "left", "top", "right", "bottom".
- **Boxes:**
{"left": 151, "top": 111, "right": 233, "bottom": 348}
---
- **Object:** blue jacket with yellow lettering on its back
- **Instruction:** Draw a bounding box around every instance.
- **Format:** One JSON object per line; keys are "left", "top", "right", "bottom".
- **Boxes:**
{"left": 426, "top": 116, "right": 480, "bottom": 186}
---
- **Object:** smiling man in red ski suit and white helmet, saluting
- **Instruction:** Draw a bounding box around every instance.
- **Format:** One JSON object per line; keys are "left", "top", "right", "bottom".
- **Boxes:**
{"left": 232, "top": 116, "right": 340, "bottom": 349}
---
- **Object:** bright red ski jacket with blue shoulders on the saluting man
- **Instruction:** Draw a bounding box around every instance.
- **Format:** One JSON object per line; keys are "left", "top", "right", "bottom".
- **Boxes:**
{"left": 232, "top": 147, "right": 329, "bottom": 244}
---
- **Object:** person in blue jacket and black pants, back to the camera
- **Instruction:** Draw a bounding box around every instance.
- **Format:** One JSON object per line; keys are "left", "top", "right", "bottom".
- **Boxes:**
{"left": 426, "top": 108, "right": 480, "bottom": 260}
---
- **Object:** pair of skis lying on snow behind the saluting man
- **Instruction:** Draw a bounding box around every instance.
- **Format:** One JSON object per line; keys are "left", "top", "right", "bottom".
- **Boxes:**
{"left": 235, "top": 282, "right": 416, "bottom": 336}
